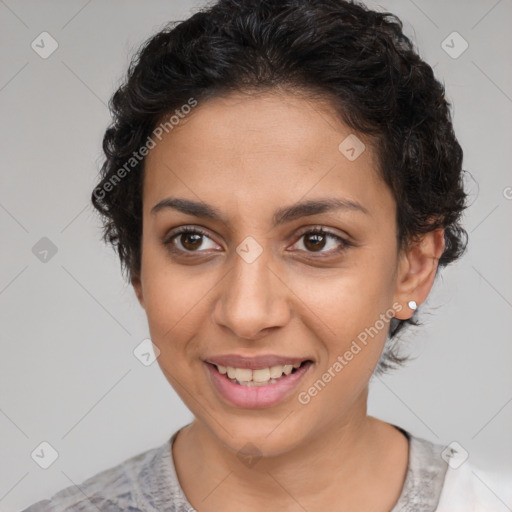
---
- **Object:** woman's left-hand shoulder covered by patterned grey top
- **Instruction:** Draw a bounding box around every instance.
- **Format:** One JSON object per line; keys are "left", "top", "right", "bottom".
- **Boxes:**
{"left": 18, "top": 441, "right": 169, "bottom": 512}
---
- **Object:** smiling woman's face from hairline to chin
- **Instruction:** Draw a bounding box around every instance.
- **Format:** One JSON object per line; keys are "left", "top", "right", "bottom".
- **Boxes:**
{"left": 134, "top": 93, "right": 424, "bottom": 454}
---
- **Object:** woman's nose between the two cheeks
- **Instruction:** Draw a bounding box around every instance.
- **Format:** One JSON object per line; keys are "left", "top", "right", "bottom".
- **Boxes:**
{"left": 214, "top": 244, "right": 290, "bottom": 340}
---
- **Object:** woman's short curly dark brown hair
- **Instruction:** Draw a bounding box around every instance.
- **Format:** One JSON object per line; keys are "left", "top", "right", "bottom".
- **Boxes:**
{"left": 91, "top": 0, "right": 467, "bottom": 372}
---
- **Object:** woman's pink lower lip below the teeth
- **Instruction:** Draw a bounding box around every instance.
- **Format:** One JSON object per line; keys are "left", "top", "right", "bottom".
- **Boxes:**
{"left": 205, "top": 361, "right": 313, "bottom": 409}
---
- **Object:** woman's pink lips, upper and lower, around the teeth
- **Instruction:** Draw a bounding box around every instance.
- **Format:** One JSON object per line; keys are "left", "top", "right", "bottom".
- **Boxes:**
{"left": 205, "top": 356, "right": 313, "bottom": 409}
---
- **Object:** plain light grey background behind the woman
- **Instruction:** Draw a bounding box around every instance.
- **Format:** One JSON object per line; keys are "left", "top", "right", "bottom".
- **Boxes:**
{"left": 0, "top": 0, "right": 512, "bottom": 511}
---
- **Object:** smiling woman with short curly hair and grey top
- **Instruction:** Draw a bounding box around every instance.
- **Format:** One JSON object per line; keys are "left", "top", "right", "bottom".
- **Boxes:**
{"left": 19, "top": 0, "right": 504, "bottom": 512}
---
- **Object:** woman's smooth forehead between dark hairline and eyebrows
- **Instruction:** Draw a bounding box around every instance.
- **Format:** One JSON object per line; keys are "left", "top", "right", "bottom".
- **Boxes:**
{"left": 143, "top": 93, "right": 394, "bottom": 222}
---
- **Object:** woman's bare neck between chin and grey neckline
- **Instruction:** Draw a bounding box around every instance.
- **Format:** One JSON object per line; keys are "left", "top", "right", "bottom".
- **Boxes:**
{"left": 173, "top": 392, "right": 408, "bottom": 512}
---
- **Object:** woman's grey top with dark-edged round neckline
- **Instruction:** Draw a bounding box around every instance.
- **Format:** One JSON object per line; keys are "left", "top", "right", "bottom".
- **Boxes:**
{"left": 22, "top": 427, "right": 448, "bottom": 512}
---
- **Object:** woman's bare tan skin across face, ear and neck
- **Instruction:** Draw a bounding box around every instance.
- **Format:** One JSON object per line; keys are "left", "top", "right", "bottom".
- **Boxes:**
{"left": 132, "top": 91, "right": 444, "bottom": 512}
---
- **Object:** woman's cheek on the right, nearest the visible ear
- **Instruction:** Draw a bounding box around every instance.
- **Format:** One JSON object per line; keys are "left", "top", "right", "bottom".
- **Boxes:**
{"left": 284, "top": 246, "right": 396, "bottom": 388}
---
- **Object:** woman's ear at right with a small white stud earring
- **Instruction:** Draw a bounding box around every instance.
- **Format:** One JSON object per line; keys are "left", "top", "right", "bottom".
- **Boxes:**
{"left": 394, "top": 228, "right": 445, "bottom": 320}
